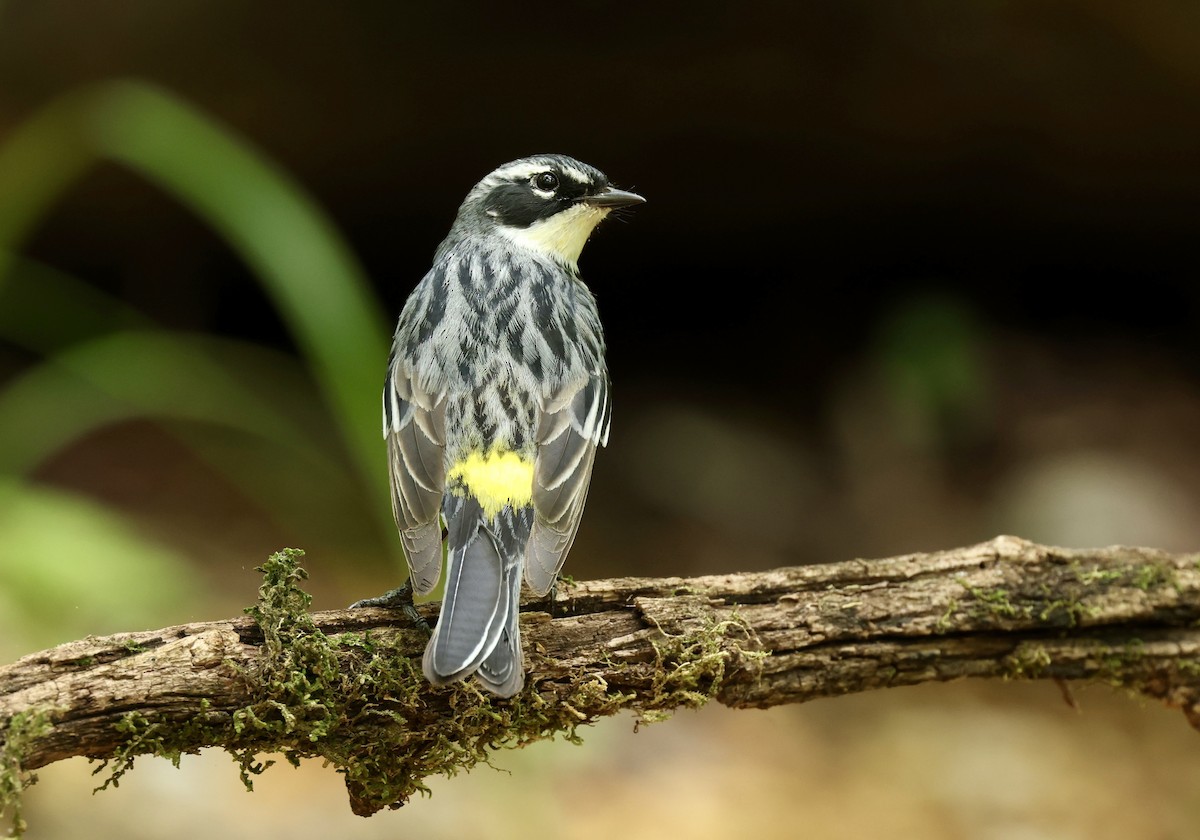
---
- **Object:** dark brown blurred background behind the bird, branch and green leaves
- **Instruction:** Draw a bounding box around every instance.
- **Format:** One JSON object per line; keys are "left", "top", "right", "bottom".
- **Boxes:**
{"left": 0, "top": 0, "right": 1200, "bottom": 838}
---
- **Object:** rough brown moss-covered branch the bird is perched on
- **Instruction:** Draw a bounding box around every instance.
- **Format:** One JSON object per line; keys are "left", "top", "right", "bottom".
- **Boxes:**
{"left": 0, "top": 536, "right": 1200, "bottom": 830}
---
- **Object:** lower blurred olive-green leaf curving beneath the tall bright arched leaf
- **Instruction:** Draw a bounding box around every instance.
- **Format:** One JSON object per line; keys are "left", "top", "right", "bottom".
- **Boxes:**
{"left": 0, "top": 330, "right": 366, "bottom": 535}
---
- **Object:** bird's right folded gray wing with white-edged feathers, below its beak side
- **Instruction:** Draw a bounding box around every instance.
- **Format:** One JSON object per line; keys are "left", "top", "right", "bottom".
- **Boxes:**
{"left": 524, "top": 372, "right": 612, "bottom": 595}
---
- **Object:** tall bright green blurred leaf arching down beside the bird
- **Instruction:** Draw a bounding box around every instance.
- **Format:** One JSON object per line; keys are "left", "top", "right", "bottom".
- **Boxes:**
{"left": 0, "top": 80, "right": 392, "bottom": 552}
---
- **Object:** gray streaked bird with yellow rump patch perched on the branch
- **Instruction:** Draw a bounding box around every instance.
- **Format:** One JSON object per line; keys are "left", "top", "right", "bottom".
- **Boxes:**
{"left": 383, "top": 155, "right": 644, "bottom": 697}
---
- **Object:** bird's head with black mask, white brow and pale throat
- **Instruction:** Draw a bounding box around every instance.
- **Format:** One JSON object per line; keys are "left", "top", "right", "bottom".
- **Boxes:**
{"left": 455, "top": 155, "right": 646, "bottom": 266}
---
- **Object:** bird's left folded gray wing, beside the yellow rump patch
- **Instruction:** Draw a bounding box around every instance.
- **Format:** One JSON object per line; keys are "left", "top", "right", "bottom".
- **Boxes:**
{"left": 383, "top": 354, "right": 446, "bottom": 595}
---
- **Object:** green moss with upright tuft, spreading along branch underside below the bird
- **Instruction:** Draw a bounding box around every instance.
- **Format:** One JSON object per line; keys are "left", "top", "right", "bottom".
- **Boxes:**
{"left": 87, "top": 550, "right": 764, "bottom": 815}
